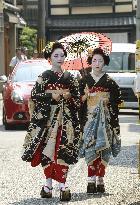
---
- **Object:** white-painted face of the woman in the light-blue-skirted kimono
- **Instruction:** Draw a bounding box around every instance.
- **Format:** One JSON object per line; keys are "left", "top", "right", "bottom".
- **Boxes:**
{"left": 91, "top": 54, "right": 104, "bottom": 72}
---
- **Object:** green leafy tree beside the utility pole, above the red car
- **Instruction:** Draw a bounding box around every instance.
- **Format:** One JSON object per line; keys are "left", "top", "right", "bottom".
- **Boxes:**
{"left": 19, "top": 27, "right": 37, "bottom": 58}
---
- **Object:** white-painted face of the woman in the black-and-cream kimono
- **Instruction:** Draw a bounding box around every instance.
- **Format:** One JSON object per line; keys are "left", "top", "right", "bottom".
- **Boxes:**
{"left": 51, "top": 48, "right": 65, "bottom": 67}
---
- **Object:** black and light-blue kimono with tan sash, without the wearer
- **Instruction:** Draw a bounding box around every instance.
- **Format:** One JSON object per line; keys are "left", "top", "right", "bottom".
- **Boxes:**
{"left": 80, "top": 73, "right": 122, "bottom": 170}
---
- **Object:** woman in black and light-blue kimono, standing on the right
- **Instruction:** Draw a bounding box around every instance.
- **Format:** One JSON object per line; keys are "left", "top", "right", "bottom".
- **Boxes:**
{"left": 80, "top": 48, "right": 121, "bottom": 194}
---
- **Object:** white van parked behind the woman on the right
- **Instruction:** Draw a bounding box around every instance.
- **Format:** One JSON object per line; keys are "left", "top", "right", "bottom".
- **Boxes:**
{"left": 105, "top": 43, "right": 138, "bottom": 109}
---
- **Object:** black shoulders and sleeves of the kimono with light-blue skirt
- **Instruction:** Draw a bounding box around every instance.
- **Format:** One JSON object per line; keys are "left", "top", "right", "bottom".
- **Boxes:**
{"left": 80, "top": 73, "right": 122, "bottom": 134}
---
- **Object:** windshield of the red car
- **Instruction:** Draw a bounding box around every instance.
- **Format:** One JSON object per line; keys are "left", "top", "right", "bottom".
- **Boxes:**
{"left": 11, "top": 63, "right": 50, "bottom": 82}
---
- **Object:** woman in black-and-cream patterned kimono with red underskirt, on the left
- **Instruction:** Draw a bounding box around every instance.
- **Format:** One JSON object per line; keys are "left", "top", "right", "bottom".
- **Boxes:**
{"left": 22, "top": 43, "right": 80, "bottom": 201}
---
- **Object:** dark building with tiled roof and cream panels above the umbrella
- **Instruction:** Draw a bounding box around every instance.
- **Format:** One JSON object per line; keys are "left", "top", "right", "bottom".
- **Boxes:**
{"left": 20, "top": 0, "right": 137, "bottom": 43}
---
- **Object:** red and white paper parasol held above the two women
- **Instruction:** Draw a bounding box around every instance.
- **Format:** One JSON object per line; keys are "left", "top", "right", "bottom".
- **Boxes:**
{"left": 59, "top": 32, "right": 112, "bottom": 70}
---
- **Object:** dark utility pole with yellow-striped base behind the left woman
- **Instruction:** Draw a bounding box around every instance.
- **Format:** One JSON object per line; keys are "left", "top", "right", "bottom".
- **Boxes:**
{"left": 37, "top": 0, "right": 46, "bottom": 57}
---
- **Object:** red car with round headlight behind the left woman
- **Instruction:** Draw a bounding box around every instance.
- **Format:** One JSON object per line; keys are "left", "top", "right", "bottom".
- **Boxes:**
{"left": 0, "top": 59, "right": 51, "bottom": 130}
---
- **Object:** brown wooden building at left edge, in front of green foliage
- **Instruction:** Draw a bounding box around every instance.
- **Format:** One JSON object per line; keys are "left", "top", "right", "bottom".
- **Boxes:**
{"left": 0, "top": 0, "right": 26, "bottom": 75}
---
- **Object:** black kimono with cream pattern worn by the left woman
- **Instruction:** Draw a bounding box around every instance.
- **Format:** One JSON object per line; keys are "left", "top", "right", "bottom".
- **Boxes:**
{"left": 22, "top": 70, "right": 80, "bottom": 168}
